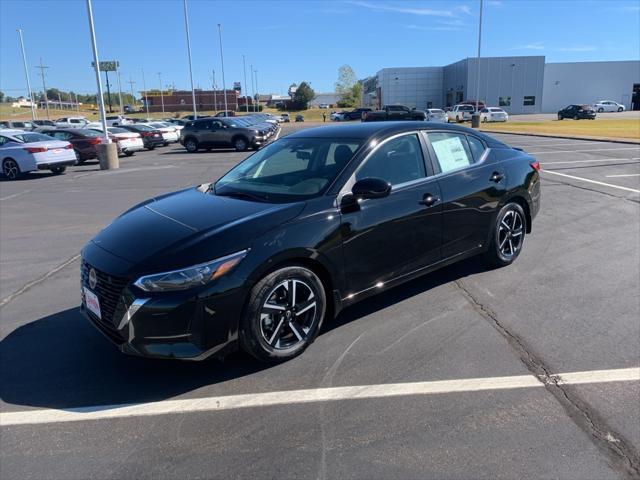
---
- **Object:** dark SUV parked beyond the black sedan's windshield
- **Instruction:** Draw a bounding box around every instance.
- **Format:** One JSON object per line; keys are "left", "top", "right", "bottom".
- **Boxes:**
{"left": 180, "top": 117, "right": 271, "bottom": 153}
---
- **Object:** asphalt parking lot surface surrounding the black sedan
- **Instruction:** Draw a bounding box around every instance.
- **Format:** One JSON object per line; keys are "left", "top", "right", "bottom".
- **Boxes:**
{"left": 0, "top": 125, "right": 640, "bottom": 479}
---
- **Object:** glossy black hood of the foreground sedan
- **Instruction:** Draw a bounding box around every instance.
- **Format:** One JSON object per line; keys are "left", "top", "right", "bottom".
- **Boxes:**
{"left": 92, "top": 186, "right": 304, "bottom": 271}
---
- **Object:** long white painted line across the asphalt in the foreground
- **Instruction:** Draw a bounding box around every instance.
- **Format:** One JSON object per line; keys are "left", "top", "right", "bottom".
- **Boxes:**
{"left": 0, "top": 367, "right": 640, "bottom": 427}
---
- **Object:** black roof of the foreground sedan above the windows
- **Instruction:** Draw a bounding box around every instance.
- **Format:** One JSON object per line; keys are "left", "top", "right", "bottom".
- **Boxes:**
{"left": 283, "top": 121, "right": 502, "bottom": 145}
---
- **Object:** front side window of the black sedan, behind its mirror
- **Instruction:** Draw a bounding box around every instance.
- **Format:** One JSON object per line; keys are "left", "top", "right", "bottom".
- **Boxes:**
{"left": 356, "top": 134, "right": 425, "bottom": 185}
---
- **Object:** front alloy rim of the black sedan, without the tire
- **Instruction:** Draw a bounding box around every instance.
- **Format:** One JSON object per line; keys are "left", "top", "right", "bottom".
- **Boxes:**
{"left": 260, "top": 279, "right": 318, "bottom": 350}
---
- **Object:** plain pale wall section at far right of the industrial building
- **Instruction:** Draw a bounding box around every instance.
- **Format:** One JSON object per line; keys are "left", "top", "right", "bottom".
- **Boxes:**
{"left": 542, "top": 60, "right": 640, "bottom": 113}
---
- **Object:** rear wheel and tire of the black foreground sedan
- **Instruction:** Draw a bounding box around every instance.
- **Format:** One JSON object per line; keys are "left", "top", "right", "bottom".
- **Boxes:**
{"left": 485, "top": 202, "right": 527, "bottom": 267}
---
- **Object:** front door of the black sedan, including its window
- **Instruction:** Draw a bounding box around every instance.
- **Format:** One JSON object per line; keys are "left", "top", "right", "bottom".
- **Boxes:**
{"left": 342, "top": 133, "right": 441, "bottom": 296}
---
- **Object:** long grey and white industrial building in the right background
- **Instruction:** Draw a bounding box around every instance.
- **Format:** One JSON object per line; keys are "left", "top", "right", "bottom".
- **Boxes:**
{"left": 362, "top": 56, "right": 640, "bottom": 114}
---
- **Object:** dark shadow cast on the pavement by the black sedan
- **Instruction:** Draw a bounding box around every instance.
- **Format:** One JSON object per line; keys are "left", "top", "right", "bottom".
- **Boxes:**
{"left": 0, "top": 258, "right": 487, "bottom": 408}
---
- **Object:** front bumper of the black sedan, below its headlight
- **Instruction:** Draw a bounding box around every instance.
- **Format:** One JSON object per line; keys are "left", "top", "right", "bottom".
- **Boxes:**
{"left": 80, "top": 251, "right": 244, "bottom": 360}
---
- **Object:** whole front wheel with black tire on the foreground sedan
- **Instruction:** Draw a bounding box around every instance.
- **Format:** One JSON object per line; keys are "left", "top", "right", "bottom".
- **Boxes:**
{"left": 240, "top": 266, "right": 327, "bottom": 362}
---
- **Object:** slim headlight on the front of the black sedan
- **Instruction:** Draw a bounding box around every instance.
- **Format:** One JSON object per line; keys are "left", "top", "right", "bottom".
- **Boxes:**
{"left": 134, "top": 250, "right": 249, "bottom": 292}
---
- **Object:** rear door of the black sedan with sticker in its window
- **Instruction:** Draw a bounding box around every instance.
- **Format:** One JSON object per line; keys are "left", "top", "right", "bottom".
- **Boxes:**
{"left": 426, "top": 131, "right": 506, "bottom": 259}
